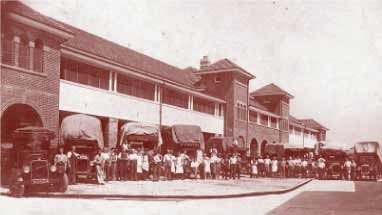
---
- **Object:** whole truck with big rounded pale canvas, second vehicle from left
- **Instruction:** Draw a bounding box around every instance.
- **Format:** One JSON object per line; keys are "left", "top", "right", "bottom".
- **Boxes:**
{"left": 60, "top": 114, "right": 104, "bottom": 180}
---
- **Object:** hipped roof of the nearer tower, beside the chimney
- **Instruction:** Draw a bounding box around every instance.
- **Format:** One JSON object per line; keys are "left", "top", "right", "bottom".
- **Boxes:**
{"left": 197, "top": 58, "right": 255, "bottom": 79}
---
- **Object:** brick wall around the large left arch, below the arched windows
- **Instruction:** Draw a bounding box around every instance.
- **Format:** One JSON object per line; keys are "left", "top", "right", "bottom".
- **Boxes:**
{"left": 1, "top": 46, "right": 60, "bottom": 144}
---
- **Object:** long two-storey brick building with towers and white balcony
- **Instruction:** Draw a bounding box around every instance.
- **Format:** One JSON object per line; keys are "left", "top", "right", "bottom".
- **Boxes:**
{"left": 1, "top": 1, "right": 327, "bottom": 160}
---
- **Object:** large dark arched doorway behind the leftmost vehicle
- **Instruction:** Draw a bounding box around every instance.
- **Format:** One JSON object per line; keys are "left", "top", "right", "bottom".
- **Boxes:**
{"left": 0, "top": 104, "right": 43, "bottom": 184}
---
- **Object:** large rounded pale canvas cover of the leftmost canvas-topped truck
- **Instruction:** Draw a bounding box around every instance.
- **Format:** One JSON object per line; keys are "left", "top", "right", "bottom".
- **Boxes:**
{"left": 60, "top": 114, "right": 104, "bottom": 148}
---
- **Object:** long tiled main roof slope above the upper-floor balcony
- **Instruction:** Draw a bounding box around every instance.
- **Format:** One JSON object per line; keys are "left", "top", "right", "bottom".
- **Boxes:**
{"left": 10, "top": 1, "right": 199, "bottom": 89}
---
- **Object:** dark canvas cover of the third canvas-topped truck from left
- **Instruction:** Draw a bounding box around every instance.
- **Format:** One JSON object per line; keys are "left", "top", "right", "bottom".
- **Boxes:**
{"left": 171, "top": 125, "right": 205, "bottom": 150}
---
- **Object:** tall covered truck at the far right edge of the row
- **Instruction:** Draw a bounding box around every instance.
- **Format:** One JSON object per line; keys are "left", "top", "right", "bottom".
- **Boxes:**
{"left": 354, "top": 141, "right": 382, "bottom": 180}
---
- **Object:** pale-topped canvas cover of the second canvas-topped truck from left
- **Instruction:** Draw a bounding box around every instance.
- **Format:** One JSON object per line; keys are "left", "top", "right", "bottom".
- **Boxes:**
{"left": 119, "top": 122, "right": 163, "bottom": 145}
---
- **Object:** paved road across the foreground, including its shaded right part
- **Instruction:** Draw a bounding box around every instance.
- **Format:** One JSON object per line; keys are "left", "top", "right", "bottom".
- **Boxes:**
{"left": 0, "top": 181, "right": 382, "bottom": 215}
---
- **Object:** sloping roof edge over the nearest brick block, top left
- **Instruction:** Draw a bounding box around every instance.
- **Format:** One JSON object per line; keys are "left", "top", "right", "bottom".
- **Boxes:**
{"left": 1, "top": 0, "right": 73, "bottom": 33}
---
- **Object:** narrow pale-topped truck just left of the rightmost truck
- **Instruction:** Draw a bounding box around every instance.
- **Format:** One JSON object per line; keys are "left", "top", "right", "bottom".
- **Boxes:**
{"left": 320, "top": 145, "right": 347, "bottom": 180}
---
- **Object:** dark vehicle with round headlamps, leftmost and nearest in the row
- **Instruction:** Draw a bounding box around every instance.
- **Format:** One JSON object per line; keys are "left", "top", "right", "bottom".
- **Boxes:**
{"left": 10, "top": 127, "right": 68, "bottom": 197}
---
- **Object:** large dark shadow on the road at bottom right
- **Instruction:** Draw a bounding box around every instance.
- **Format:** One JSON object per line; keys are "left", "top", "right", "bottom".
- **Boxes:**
{"left": 268, "top": 181, "right": 382, "bottom": 215}
